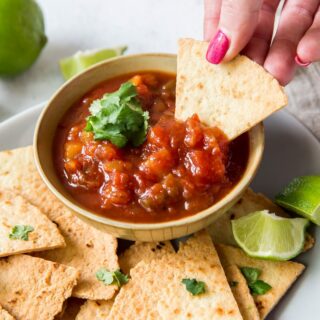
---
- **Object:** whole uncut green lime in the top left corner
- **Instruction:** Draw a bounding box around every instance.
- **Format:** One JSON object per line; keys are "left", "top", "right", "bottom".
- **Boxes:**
{"left": 0, "top": 0, "right": 47, "bottom": 76}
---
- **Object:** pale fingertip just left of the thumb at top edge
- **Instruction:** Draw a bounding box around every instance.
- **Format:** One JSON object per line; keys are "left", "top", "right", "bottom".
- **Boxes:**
{"left": 203, "top": 0, "right": 222, "bottom": 41}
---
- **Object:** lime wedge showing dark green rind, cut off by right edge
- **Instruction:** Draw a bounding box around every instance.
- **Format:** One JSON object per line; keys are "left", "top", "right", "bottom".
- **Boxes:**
{"left": 276, "top": 176, "right": 320, "bottom": 226}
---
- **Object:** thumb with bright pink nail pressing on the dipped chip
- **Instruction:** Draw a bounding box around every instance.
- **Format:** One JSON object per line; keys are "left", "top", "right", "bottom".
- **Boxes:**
{"left": 207, "top": 0, "right": 262, "bottom": 64}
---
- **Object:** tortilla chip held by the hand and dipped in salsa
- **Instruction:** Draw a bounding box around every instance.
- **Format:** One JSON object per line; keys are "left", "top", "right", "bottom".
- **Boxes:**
{"left": 175, "top": 39, "right": 288, "bottom": 140}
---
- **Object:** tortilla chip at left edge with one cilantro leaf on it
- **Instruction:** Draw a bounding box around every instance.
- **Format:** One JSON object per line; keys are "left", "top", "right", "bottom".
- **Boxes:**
{"left": 0, "top": 190, "right": 65, "bottom": 257}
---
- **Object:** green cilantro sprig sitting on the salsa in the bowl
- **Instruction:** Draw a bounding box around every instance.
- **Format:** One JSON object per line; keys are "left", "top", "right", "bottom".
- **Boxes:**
{"left": 85, "top": 82, "right": 149, "bottom": 148}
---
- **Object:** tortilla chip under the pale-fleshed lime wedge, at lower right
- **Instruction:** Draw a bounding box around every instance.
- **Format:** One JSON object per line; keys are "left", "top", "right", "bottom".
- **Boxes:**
{"left": 216, "top": 245, "right": 305, "bottom": 319}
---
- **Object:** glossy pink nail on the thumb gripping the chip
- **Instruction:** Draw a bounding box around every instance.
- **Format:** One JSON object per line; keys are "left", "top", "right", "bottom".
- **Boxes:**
{"left": 206, "top": 30, "right": 229, "bottom": 64}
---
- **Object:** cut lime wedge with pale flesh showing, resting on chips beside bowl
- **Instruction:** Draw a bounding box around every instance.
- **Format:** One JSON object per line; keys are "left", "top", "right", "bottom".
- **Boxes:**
{"left": 232, "top": 210, "right": 309, "bottom": 261}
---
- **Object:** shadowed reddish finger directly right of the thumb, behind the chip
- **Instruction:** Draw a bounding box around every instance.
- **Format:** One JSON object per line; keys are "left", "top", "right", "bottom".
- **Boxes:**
{"left": 243, "top": 0, "right": 280, "bottom": 64}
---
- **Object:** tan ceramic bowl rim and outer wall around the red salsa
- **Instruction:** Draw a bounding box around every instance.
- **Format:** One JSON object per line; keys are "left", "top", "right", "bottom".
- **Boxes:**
{"left": 34, "top": 54, "right": 264, "bottom": 241}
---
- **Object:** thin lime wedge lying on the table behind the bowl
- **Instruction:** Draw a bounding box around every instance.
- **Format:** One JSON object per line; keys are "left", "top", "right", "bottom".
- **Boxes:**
{"left": 60, "top": 46, "right": 127, "bottom": 80}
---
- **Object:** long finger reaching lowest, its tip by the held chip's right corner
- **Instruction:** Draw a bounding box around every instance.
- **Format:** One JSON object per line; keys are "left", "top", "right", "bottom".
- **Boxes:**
{"left": 264, "top": 0, "right": 319, "bottom": 85}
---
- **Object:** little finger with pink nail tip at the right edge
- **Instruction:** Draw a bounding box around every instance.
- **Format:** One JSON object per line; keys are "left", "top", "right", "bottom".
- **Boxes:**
{"left": 297, "top": 8, "right": 320, "bottom": 66}
